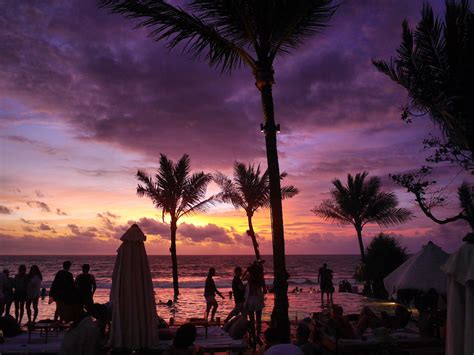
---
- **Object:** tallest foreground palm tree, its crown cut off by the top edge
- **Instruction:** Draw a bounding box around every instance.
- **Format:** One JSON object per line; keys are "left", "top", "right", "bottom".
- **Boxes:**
{"left": 99, "top": 0, "right": 337, "bottom": 341}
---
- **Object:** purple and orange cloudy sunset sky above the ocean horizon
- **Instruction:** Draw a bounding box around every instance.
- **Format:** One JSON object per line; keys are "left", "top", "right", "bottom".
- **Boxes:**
{"left": 0, "top": 0, "right": 469, "bottom": 254}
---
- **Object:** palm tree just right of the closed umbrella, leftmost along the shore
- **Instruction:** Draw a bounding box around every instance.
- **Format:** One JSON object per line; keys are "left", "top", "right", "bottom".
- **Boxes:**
{"left": 137, "top": 154, "right": 215, "bottom": 297}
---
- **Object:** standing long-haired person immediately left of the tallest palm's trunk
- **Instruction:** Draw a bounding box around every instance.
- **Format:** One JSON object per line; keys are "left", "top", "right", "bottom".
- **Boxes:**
{"left": 242, "top": 261, "right": 267, "bottom": 345}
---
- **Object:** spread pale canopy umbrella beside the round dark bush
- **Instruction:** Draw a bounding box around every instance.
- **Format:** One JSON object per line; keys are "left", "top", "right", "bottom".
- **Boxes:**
{"left": 383, "top": 242, "right": 449, "bottom": 296}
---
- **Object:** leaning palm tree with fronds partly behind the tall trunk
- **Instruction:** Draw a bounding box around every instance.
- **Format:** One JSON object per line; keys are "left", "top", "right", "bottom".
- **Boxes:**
{"left": 214, "top": 161, "right": 298, "bottom": 260}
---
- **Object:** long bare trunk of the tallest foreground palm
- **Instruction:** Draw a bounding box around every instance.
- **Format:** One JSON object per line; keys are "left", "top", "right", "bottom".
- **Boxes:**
{"left": 255, "top": 68, "right": 290, "bottom": 342}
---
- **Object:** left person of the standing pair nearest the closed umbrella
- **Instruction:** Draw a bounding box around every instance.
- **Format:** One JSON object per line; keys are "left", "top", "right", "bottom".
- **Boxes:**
{"left": 49, "top": 261, "right": 77, "bottom": 320}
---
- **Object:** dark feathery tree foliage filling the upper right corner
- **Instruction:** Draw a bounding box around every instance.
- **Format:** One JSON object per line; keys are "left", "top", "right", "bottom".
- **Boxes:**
{"left": 373, "top": 0, "right": 474, "bottom": 171}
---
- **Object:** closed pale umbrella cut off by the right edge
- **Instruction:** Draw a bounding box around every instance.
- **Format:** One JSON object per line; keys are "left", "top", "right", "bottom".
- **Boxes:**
{"left": 443, "top": 233, "right": 474, "bottom": 355}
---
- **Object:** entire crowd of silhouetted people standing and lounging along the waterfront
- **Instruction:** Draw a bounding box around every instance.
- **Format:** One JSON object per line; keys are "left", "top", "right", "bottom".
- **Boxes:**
{"left": 0, "top": 260, "right": 418, "bottom": 355}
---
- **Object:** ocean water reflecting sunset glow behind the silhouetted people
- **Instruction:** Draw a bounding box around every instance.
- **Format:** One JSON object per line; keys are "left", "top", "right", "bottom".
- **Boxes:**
{"left": 0, "top": 255, "right": 382, "bottom": 322}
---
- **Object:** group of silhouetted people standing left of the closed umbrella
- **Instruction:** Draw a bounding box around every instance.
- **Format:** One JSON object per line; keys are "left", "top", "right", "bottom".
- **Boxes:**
{"left": 0, "top": 261, "right": 97, "bottom": 324}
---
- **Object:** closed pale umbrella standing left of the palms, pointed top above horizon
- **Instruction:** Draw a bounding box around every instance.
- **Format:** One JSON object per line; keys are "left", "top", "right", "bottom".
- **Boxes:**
{"left": 109, "top": 224, "right": 157, "bottom": 349}
